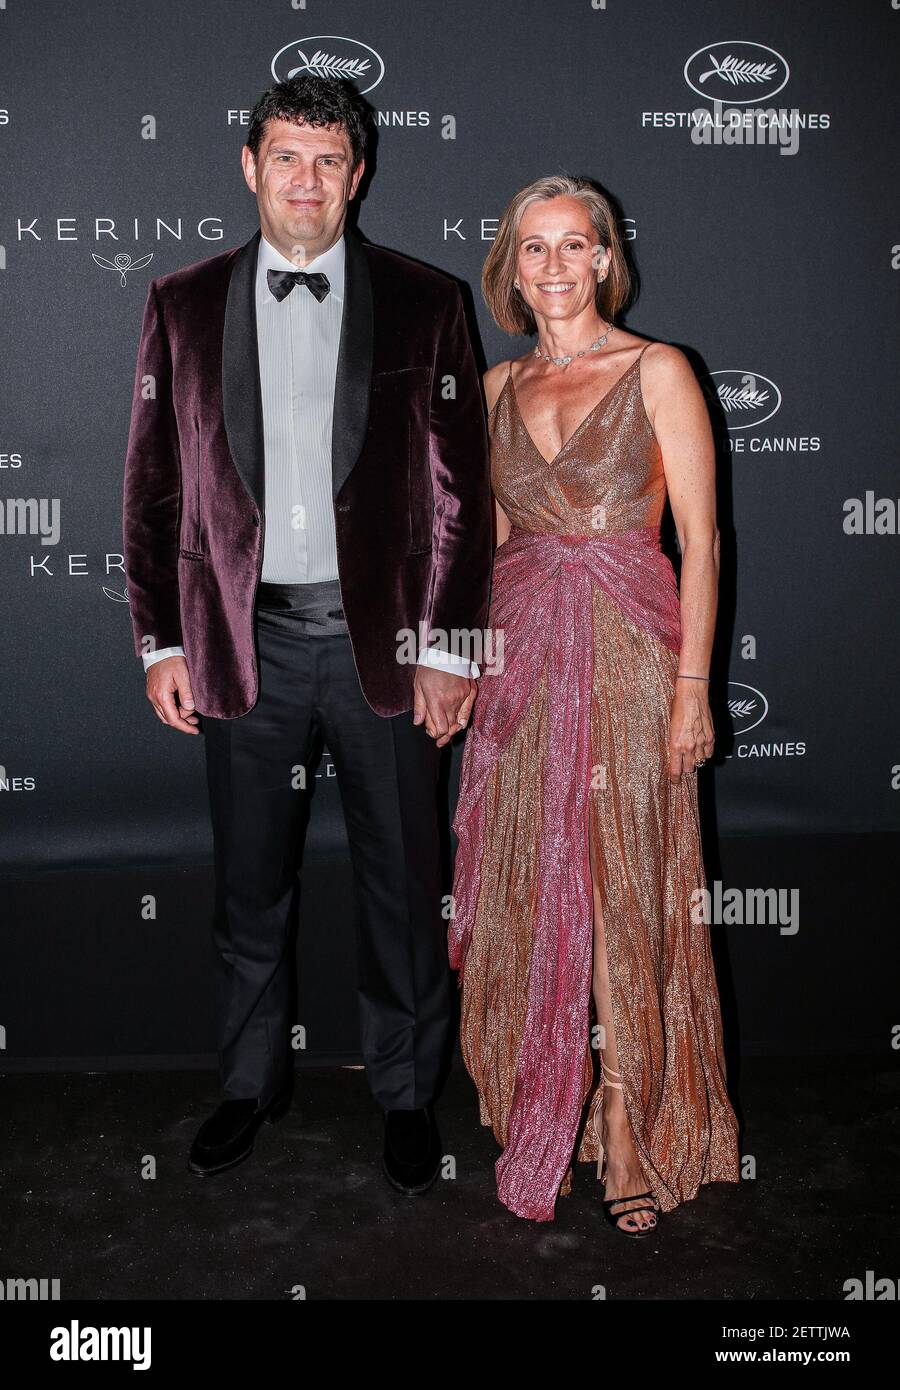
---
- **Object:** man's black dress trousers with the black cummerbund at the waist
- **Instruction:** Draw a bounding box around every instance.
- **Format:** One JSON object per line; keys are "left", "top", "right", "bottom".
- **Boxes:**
{"left": 202, "top": 582, "right": 451, "bottom": 1109}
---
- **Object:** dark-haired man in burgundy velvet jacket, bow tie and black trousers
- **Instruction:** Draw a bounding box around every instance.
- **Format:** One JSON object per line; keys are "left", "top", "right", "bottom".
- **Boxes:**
{"left": 124, "top": 76, "right": 491, "bottom": 1193}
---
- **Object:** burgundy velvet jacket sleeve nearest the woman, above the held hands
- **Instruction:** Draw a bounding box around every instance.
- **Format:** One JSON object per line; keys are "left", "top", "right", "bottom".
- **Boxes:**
{"left": 424, "top": 285, "right": 492, "bottom": 662}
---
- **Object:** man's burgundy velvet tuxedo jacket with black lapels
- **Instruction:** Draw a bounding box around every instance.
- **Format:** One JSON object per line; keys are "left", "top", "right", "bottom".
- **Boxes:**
{"left": 122, "top": 228, "right": 492, "bottom": 719}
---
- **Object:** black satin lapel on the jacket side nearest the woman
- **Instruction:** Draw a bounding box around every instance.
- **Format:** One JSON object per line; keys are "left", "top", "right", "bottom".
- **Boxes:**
{"left": 331, "top": 231, "right": 374, "bottom": 498}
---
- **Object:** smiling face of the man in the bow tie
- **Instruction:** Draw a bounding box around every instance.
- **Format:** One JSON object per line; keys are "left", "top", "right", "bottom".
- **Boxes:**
{"left": 241, "top": 121, "right": 366, "bottom": 265}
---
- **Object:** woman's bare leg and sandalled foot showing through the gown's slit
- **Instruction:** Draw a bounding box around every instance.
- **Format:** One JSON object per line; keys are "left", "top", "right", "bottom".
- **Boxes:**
{"left": 590, "top": 817, "right": 657, "bottom": 1230}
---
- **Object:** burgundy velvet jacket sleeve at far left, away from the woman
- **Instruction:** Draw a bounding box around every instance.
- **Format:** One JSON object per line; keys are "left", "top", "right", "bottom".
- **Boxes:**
{"left": 122, "top": 281, "right": 182, "bottom": 656}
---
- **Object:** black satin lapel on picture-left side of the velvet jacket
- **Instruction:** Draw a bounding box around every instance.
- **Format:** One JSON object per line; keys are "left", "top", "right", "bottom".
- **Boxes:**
{"left": 223, "top": 231, "right": 266, "bottom": 513}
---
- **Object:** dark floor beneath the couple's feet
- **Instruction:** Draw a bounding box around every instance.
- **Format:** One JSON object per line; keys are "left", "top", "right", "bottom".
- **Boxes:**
{"left": 0, "top": 1054, "right": 900, "bottom": 1301}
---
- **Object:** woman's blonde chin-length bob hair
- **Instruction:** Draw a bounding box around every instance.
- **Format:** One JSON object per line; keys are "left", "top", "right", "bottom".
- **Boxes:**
{"left": 481, "top": 174, "right": 632, "bottom": 336}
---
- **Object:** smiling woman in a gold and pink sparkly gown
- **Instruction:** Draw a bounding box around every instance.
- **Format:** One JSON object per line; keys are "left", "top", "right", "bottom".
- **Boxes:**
{"left": 451, "top": 177, "right": 739, "bottom": 1236}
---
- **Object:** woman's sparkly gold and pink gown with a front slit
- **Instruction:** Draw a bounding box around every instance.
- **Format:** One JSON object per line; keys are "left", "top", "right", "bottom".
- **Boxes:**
{"left": 449, "top": 349, "right": 739, "bottom": 1220}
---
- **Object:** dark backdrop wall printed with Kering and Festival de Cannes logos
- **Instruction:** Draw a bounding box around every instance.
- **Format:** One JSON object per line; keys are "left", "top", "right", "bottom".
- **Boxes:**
{"left": 0, "top": 0, "right": 900, "bottom": 1051}
